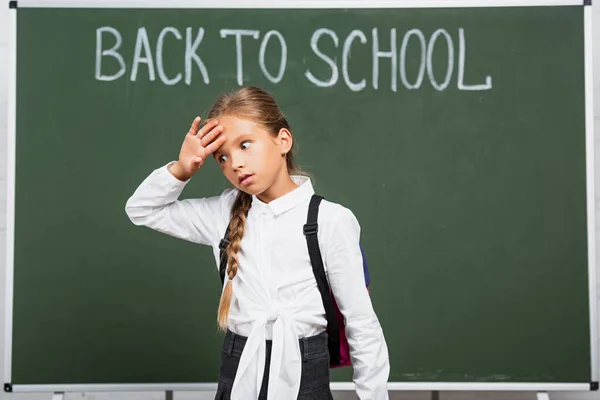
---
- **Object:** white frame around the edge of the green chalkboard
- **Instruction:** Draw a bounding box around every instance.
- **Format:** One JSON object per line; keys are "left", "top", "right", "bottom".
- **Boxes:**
{"left": 4, "top": 0, "right": 598, "bottom": 392}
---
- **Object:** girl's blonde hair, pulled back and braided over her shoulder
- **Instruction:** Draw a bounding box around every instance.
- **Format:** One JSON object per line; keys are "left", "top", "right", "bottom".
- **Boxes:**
{"left": 206, "top": 86, "right": 301, "bottom": 331}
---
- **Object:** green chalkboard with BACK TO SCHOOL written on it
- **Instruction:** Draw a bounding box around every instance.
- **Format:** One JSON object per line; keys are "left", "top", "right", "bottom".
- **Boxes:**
{"left": 9, "top": 6, "right": 591, "bottom": 385}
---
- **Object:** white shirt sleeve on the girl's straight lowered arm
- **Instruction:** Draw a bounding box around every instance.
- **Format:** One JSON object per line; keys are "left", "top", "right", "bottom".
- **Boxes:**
{"left": 323, "top": 207, "right": 390, "bottom": 400}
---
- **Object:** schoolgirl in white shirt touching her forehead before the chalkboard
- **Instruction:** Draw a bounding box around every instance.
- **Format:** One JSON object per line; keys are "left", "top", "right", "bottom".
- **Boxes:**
{"left": 126, "top": 87, "right": 390, "bottom": 400}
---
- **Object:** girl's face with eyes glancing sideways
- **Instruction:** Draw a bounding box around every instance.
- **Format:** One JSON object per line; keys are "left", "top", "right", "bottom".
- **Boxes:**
{"left": 213, "top": 115, "right": 292, "bottom": 201}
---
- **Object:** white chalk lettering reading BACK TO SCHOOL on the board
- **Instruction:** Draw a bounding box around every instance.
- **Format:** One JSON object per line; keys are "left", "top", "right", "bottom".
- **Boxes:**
{"left": 94, "top": 26, "right": 492, "bottom": 93}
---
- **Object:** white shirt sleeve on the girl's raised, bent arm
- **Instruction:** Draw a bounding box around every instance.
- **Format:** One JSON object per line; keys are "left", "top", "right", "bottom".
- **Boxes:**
{"left": 125, "top": 164, "right": 231, "bottom": 245}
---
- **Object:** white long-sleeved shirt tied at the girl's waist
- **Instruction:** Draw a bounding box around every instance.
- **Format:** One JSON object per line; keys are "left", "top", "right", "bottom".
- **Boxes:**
{"left": 125, "top": 164, "right": 390, "bottom": 400}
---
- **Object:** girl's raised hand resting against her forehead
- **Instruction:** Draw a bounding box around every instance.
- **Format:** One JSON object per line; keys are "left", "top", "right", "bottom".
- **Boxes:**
{"left": 169, "top": 117, "right": 225, "bottom": 181}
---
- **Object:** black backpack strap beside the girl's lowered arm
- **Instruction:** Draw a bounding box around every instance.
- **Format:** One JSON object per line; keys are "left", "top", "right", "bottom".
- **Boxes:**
{"left": 304, "top": 194, "right": 340, "bottom": 365}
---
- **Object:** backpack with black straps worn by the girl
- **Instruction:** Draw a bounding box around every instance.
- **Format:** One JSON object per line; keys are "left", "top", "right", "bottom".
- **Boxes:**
{"left": 219, "top": 194, "right": 370, "bottom": 368}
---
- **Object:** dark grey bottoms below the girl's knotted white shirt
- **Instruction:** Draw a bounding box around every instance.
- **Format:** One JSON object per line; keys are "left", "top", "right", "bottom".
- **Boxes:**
{"left": 215, "top": 330, "right": 333, "bottom": 400}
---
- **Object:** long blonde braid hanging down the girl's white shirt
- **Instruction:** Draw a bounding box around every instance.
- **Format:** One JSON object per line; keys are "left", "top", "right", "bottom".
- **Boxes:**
{"left": 217, "top": 190, "right": 252, "bottom": 331}
